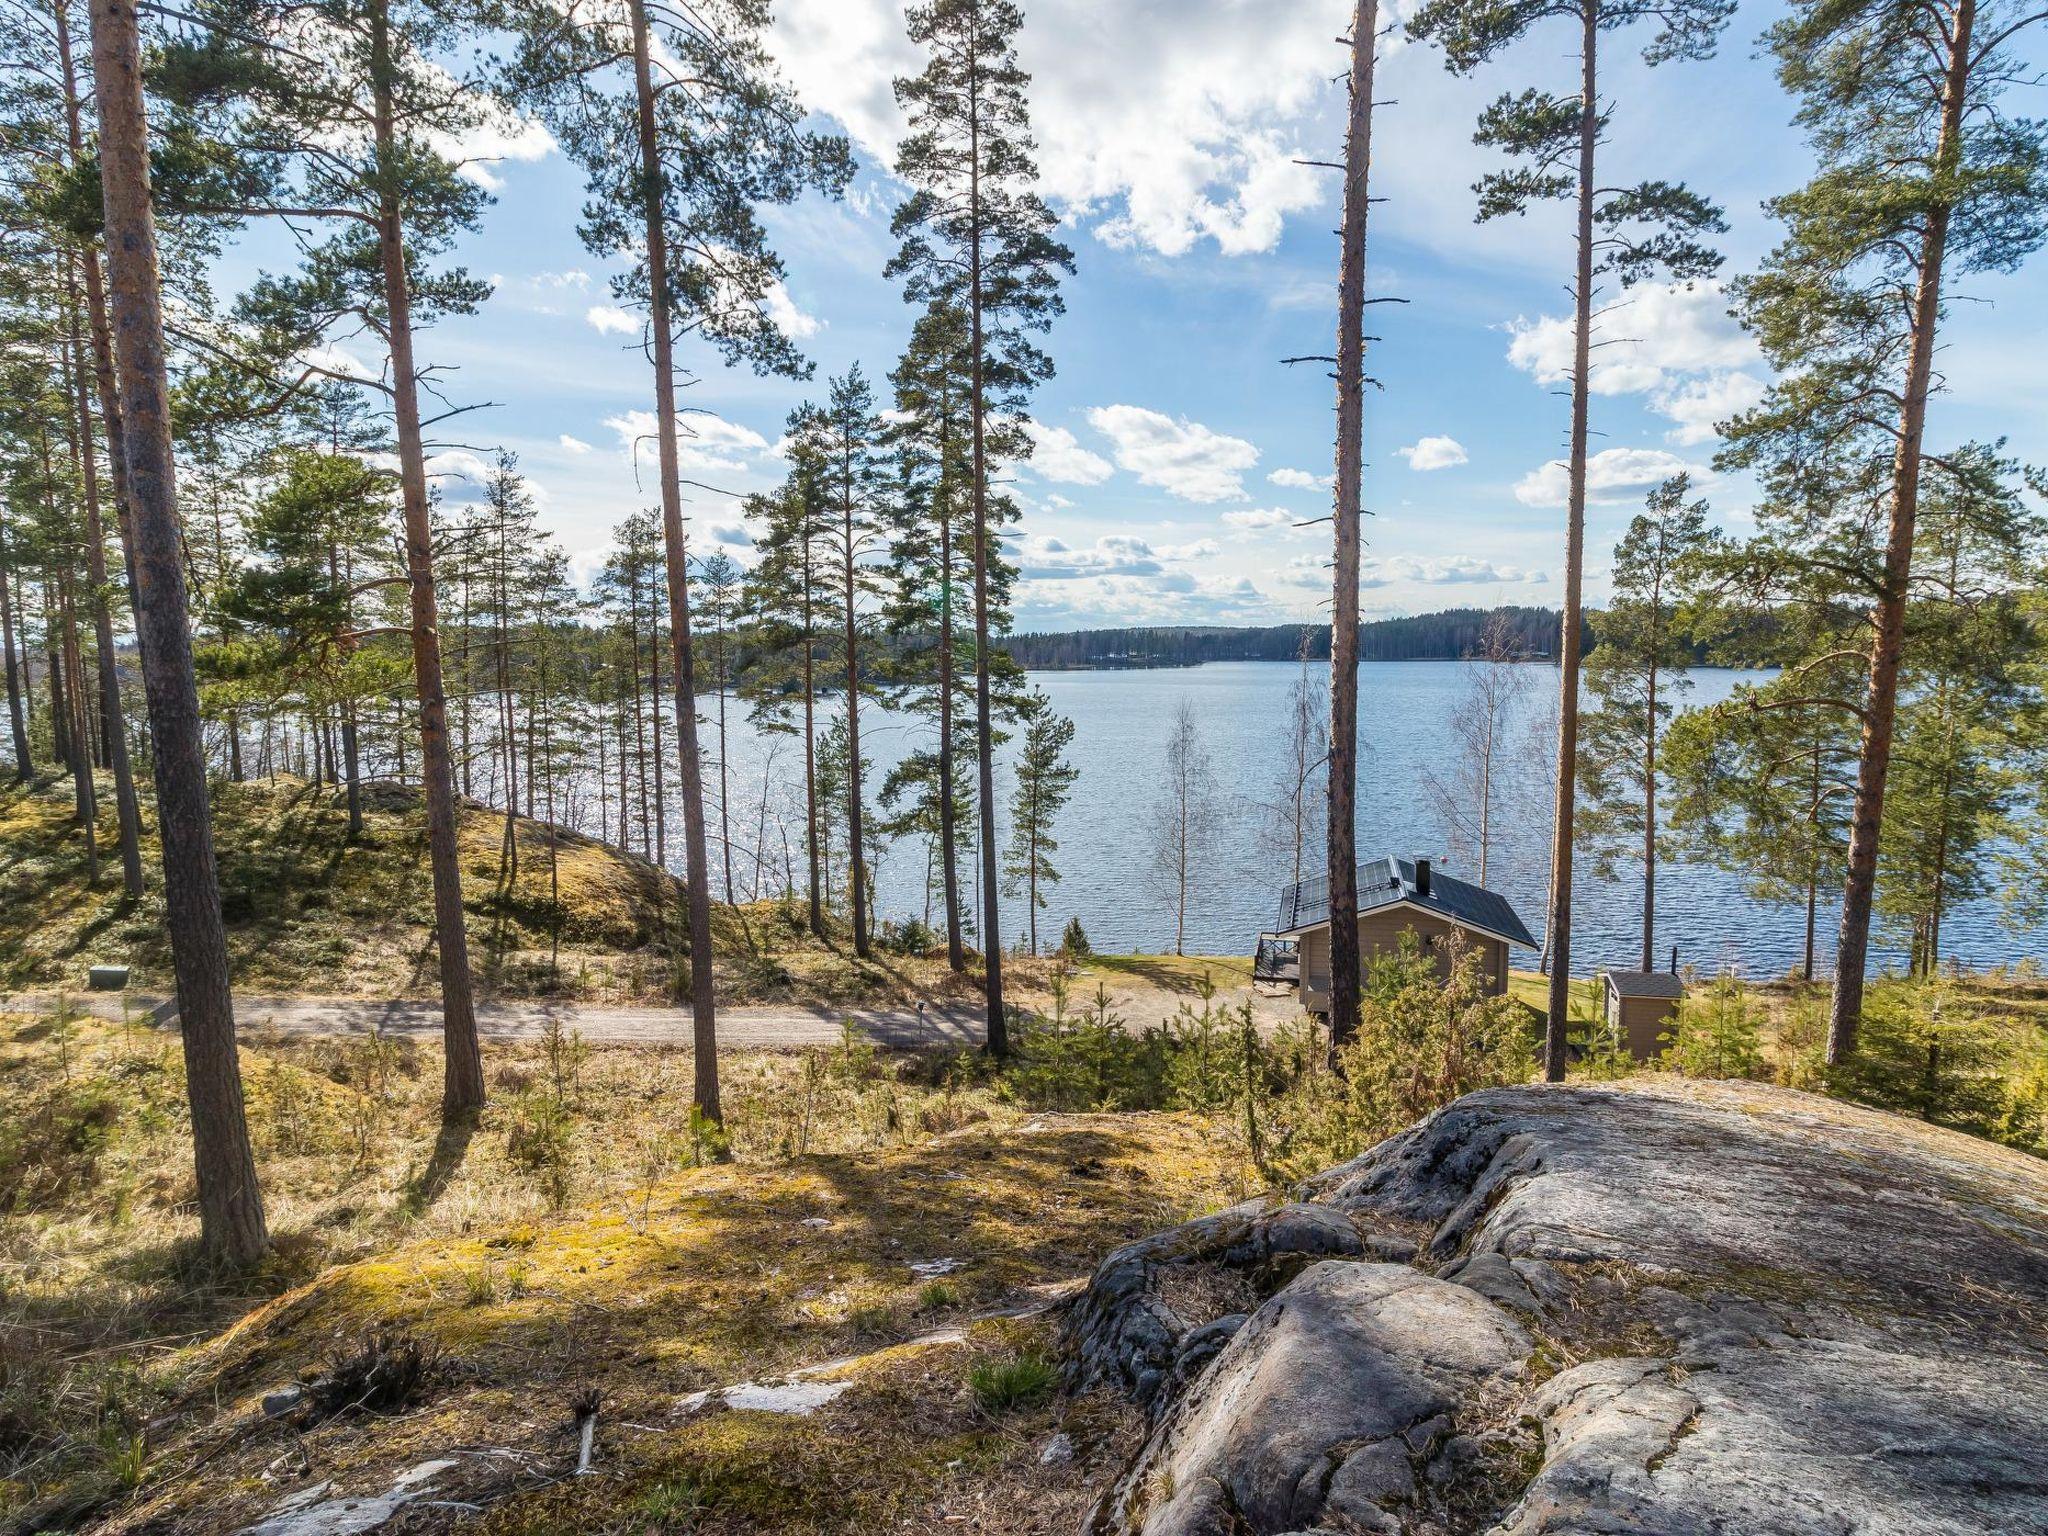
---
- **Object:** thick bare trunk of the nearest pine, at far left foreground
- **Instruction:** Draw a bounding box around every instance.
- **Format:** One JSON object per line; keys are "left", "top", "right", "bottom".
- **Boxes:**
{"left": 92, "top": 0, "right": 270, "bottom": 1264}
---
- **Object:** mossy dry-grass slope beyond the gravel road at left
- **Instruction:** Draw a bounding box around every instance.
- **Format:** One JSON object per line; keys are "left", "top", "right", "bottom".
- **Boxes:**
{"left": 0, "top": 778, "right": 1049, "bottom": 1006}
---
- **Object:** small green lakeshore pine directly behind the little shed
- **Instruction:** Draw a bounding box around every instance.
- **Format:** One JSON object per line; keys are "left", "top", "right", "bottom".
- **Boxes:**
{"left": 1579, "top": 475, "right": 1712, "bottom": 971}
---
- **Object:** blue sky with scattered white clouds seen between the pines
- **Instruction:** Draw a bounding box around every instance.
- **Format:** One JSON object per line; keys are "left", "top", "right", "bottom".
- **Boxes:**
{"left": 251, "top": 0, "right": 2048, "bottom": 629}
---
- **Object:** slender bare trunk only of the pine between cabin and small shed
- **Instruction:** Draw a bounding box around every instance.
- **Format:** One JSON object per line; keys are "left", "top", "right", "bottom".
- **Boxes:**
{"left": 1542, "top": 0, "right": 1599, "bottom": 1083}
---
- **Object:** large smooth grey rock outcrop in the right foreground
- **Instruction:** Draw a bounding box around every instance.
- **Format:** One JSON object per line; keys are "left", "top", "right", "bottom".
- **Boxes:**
{"left": 1069, "top": 1079, "right": 2048, "bottom": 1536}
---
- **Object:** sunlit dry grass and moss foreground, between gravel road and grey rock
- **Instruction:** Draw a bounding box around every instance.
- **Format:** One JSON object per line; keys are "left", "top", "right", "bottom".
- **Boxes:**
{"left": 0, "top": 1020, "right": 1247, "bottom": 1532}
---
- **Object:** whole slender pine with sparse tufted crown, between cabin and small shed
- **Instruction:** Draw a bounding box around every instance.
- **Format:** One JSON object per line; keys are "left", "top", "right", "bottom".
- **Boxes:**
{"left": 1409, "top": 0, "right": 1735, "bottom": 1081}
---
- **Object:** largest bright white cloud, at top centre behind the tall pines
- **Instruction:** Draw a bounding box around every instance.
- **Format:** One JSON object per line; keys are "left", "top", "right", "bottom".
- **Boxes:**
{"left": 772, "top": 0, "right": 1343, "bottom": 256}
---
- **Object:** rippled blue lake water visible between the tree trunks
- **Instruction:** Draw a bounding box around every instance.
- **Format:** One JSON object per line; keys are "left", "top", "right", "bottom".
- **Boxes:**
{"left": 705, "top": 662, "right": 2048, "bottom": 975}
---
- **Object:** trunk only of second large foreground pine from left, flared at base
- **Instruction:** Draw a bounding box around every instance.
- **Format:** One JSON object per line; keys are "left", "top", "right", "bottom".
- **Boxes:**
{"left": 371, "top": 0, "right": 483, "bottom": 1120}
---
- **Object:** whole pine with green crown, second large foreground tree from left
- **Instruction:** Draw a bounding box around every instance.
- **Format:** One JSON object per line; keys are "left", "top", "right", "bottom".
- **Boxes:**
{"left": 160, "top": 0, "right": 524, "bottom": 1120}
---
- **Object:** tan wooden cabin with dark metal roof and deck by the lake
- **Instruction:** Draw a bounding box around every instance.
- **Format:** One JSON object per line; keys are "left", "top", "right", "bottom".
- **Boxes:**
{"left": 1260, "top": 856, "right": 1536, "bottom": 1014}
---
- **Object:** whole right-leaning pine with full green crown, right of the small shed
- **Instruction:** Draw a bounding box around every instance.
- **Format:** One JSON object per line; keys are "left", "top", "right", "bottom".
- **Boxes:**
{"left": 1724, "top": 0, "right": 2048, "bottom": 1065}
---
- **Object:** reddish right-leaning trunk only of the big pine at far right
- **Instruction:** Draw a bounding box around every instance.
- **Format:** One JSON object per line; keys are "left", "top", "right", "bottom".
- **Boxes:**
{"left": 1827, "top": 0, "right": 1976, "bottom": 1067}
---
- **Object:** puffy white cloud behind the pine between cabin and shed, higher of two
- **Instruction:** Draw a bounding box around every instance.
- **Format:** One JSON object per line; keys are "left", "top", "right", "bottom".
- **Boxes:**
{"left": 1507, "top": 283, "right": 1763, "bottom": 446}
